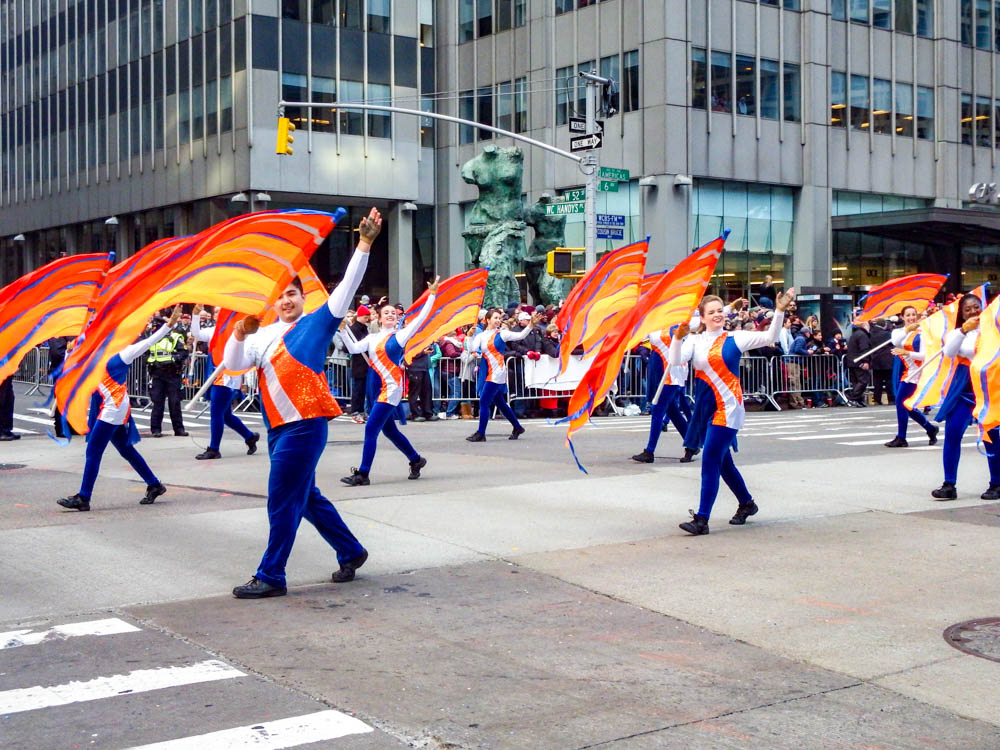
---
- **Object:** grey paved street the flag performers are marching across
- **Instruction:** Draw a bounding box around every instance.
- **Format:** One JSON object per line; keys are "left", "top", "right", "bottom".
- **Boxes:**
{"left": 0, "top": 392, "right": 1000, "bottom": 750}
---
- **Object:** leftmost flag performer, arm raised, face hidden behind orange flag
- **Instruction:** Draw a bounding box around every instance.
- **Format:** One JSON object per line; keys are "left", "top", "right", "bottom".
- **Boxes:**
{"left": 56, "top": 305, "right": 181, "bottom": 511}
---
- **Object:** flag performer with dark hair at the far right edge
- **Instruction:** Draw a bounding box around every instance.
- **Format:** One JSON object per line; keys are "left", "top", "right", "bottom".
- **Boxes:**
{"left": 931, "top": 294, "right": 1000, "bottom": 500}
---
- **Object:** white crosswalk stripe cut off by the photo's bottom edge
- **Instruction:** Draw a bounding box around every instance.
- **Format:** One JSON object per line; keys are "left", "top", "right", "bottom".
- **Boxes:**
{"left": 124, "top": 710, "right": 374, "bottom": 750}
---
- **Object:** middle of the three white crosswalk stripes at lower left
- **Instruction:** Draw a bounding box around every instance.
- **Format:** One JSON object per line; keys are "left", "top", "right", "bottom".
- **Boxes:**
{"left": 0, "top": 659, "right": 245, "bottom": 716}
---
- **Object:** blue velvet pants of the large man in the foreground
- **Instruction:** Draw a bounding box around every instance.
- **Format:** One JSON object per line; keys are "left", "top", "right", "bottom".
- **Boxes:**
{"left": 256, "top": 417, "right": 364, "bottom": 586}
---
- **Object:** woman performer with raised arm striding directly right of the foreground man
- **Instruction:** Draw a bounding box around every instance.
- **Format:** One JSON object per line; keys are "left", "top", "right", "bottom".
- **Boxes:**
{"left": 340, "top": 277, "right": 440, "bottom": 487}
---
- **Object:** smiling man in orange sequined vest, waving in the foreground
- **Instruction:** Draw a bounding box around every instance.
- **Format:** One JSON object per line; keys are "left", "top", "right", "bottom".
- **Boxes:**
{"left": 223, "top": 208, "right": 382, "bottom": 599}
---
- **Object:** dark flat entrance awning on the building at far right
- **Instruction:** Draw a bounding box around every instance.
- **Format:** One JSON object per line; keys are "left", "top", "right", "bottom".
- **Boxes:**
{"left": 832, "top": 208, "right": 1000, "bottom": 247}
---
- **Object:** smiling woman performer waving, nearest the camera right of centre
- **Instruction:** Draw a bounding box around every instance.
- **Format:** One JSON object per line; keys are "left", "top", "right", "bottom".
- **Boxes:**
{"left": 669, "top": 289, "right": 795, "bottom": 535}
